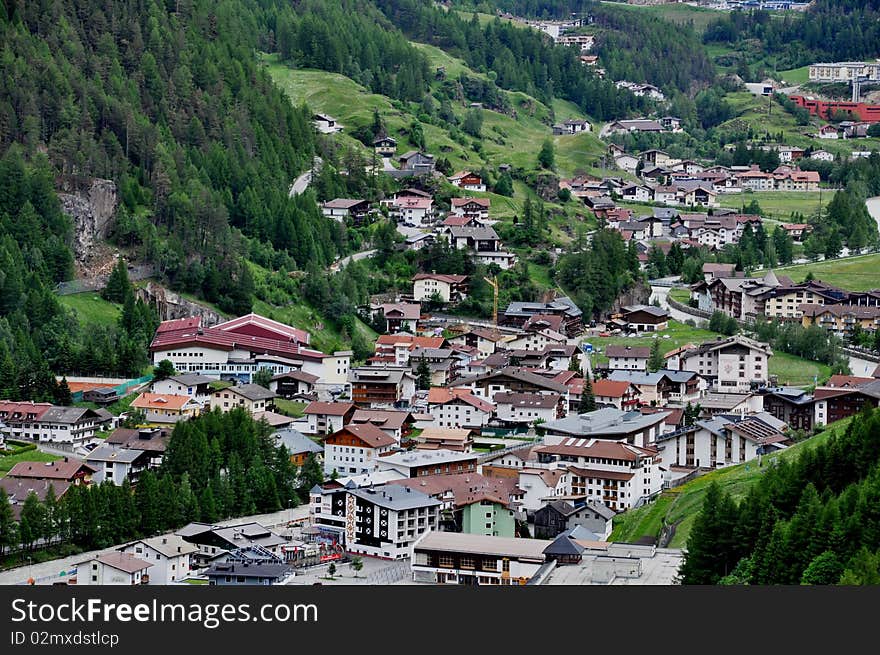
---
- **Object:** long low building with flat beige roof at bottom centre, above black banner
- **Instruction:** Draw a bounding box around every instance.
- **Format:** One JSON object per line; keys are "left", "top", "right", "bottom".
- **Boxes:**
{"left": 410, "top": 531, "right": 550, "bottom": 585}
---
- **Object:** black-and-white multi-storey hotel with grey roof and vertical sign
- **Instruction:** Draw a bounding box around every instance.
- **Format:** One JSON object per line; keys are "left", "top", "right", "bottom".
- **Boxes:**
{"left": 345, "top": 484, "right": 441, "bottom": 560}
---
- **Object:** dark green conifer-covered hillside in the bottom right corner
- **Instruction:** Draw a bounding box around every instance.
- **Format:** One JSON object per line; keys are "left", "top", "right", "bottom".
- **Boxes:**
{"left": 680, "top": 407, "right": 880, "bottom": 584}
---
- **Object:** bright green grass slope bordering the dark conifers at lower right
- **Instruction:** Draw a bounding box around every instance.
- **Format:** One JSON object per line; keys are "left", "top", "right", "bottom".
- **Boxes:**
{"left": 611, "top": 419, "right": 849, "bottom": 548}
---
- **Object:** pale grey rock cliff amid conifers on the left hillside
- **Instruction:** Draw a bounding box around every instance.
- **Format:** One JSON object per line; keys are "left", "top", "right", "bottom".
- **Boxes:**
{"left": 58, "top": 176, "right": 118, "bottom": 265}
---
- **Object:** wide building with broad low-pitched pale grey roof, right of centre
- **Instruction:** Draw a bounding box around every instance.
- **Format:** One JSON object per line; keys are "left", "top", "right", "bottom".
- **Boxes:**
{"left": 541, "top": 407, "right": 669, "bottom": 448}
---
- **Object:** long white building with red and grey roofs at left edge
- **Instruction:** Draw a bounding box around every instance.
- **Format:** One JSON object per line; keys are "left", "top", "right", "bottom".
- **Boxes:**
{"left": 0, "top": 400, "right": 104, "bottom": 446}
